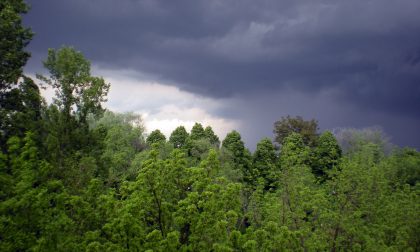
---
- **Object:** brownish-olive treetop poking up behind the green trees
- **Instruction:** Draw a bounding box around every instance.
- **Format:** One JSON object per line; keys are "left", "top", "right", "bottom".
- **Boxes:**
{"left": 273, "top": 116, "right": 318, "bottom": 146}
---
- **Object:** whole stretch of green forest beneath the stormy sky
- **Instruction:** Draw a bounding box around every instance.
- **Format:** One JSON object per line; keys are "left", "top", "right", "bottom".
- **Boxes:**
{"left": 0, "top": 0, "right": 420, "bottom": 251}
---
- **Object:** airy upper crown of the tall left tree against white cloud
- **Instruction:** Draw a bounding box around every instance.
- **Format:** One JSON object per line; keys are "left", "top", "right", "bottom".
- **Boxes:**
{"left": 37, "top": 47, "right": 110, "bottom": 124}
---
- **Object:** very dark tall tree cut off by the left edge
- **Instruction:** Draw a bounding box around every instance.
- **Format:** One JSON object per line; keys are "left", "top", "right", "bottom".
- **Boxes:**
{"left": 0, "top": 0, "right": 41, "bottom": 152}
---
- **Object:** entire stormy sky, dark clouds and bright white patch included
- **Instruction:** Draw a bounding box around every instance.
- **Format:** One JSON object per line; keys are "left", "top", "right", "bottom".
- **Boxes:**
{"left": 24, "top": 0, "right": 420, "bottom": 149}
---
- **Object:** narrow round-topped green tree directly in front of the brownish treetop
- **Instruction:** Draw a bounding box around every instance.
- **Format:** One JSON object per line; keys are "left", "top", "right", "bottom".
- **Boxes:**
{"left": 279, "top": 132, "right": 326, "bottom": 250}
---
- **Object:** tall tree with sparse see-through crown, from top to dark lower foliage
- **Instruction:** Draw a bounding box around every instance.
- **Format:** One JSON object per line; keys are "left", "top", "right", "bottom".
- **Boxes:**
{"left": 38, "top": 47, "right": 109, "bottom": 177}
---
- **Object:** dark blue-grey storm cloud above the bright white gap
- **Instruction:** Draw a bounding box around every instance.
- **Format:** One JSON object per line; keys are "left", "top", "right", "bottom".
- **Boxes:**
{"left": 25, "top": 0, "right": 420, "bottom": 148}
